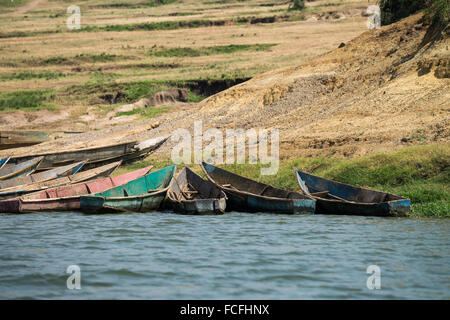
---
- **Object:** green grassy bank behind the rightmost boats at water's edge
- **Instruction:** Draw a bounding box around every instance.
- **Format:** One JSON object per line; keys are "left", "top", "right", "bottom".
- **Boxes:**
{"left": 116, "top": 143, "right": 450, "bottom": 217}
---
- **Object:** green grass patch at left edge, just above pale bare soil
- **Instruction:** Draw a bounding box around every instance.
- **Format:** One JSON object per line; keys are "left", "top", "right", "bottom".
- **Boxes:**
{"left": 0, "top": 90, "right": 56, "bottom": 111}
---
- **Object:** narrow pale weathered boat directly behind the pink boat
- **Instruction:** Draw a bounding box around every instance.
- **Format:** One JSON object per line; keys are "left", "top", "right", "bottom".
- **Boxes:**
{"left": 0, "top": 161, "right": 121, "bottom": 200}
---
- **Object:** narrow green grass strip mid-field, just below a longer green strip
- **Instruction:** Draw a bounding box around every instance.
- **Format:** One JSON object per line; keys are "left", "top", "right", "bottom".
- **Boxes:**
{"left": 148, "top": 43, "right": 277, "bottom": 57}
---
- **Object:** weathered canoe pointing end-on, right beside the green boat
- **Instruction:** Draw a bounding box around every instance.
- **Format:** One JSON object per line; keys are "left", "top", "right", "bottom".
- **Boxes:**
{"left": 167, "top": 167, "right": 227, "bottom": 215}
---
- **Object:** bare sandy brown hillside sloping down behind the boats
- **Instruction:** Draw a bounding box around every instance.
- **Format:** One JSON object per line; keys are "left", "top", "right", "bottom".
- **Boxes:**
{"left": 1, "top": 10, "right": 450, "bottom": 158}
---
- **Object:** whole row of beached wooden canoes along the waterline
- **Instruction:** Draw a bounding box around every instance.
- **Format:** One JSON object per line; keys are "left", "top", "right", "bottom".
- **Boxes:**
{"left": 0, "top": 149, "right": 410, "bottom": 216}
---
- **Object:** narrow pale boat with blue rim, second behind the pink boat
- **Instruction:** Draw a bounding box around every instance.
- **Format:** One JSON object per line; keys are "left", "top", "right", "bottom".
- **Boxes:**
{"left": 0, "top": 161, "right": 86, "bottom": 193}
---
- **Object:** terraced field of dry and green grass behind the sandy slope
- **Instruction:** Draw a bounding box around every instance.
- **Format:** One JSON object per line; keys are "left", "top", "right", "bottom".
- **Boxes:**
{"left": 0, "top": 0, "right": 367, "bottom": 131}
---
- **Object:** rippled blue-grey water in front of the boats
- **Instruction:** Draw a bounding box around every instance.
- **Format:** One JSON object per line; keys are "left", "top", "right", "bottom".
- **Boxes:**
{"left": 0, "top": 212, "right": 450, "bottom": 299}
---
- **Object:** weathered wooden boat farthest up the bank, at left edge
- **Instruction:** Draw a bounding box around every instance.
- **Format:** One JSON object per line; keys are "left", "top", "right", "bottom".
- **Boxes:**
{"left": 0, "top": 131, "right": 50, "bottom": 150}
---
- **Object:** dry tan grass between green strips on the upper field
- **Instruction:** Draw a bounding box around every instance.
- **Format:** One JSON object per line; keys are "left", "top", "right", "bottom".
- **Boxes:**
{"left": 0, "top": 0, "right": 366, "bottom": 127}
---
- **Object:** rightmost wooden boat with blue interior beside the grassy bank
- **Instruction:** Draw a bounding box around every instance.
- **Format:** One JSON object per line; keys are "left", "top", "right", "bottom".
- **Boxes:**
{"left": 294, "top": 168, "right": 411, "bottom": 217}
